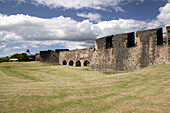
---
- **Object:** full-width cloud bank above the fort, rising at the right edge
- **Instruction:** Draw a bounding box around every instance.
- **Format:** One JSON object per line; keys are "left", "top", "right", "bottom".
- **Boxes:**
{"left": 0, "top": 3, "right": 170, "bottom": 56}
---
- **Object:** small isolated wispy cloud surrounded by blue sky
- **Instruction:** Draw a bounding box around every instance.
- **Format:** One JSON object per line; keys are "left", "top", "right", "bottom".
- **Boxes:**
{"left": 77, "top": 13, "right": 101, "bottom": 22}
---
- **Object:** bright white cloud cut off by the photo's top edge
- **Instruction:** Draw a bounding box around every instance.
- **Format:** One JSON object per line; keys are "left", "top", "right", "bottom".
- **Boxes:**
{"left": 33, "top": 0, "right": 120, "bottom": 9}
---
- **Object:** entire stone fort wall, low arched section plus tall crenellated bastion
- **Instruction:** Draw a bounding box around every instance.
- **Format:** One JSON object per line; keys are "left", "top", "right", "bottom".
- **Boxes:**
{"left": 40, "top": 26, "right": 170, "bottom": 71}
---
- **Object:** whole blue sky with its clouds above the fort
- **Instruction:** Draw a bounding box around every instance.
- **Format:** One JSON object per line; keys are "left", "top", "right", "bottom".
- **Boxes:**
{"left": 0, "top": 0, "right": 170, "bottom": 57}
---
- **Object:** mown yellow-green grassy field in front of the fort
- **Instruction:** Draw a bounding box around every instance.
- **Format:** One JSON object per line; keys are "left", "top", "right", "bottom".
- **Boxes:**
{"left": 0, "top": 62, "right": 170, "bottom": 113}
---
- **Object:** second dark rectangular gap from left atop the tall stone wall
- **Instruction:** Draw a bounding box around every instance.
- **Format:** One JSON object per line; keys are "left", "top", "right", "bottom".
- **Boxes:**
{"left": 127, "top": 33, "right": 135, "bottom": 47}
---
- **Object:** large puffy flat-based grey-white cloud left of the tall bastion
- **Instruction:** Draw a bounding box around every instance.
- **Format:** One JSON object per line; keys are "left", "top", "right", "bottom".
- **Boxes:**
{"left": 0, "top": 14, "right": 96, "bottom": 41}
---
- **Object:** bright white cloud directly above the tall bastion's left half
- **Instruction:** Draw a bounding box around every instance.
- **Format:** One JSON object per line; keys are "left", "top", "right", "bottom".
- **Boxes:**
{"left": 94, "top": 19, "right": 147, "bottom": 37}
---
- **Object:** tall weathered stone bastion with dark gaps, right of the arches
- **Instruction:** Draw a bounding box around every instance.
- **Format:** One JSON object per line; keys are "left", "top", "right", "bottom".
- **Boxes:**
{"left": 90, "top": 27, "right": 170, "bottom": 71}
